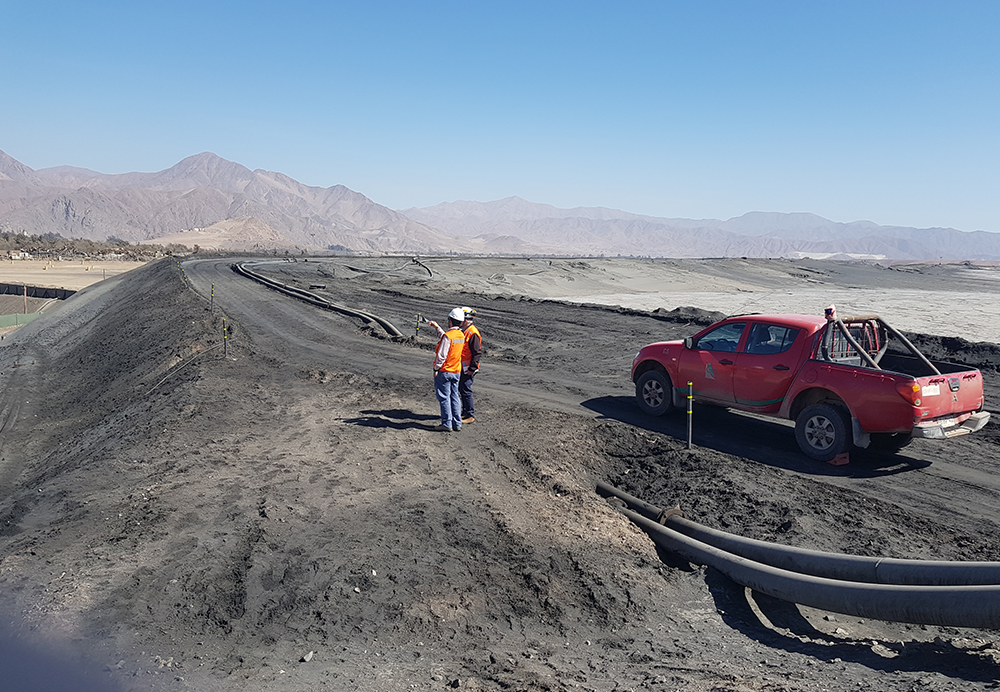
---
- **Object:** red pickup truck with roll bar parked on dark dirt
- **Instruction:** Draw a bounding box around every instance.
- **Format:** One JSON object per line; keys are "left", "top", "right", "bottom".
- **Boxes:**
{"left": 632, "top": 306, "right": 990, "bottom": 461}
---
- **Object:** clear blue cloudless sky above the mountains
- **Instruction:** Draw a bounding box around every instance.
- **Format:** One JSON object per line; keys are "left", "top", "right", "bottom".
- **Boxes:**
{"left": 0, "top": 0, "right": 1000, "bottom": 231}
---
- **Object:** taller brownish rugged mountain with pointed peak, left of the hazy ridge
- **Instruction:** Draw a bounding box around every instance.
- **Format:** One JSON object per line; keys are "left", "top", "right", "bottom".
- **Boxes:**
{"left": 0, "top": 152, "right": 454, "bottom": 253}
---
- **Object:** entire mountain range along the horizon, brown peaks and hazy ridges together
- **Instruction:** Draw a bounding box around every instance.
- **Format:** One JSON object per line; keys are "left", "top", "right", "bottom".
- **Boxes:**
{"left": 0, "top": 151, "right": 1000, "bottom": 261}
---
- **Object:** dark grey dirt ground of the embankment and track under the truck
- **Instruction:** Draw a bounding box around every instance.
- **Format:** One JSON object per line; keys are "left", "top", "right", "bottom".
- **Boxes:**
{"left": 0, "top": 259, "right": 1000, "bottom": 691}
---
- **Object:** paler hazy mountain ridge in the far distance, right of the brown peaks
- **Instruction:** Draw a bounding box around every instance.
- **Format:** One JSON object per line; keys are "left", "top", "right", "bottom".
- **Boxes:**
{"left": 401, "top": 197, "right": 1000, "bottom": 261}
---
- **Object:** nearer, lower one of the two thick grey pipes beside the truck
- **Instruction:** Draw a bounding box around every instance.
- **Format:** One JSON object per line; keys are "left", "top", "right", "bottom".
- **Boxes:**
{"left": 598, "top": 484, "right": 1000, "bottom": 628}
